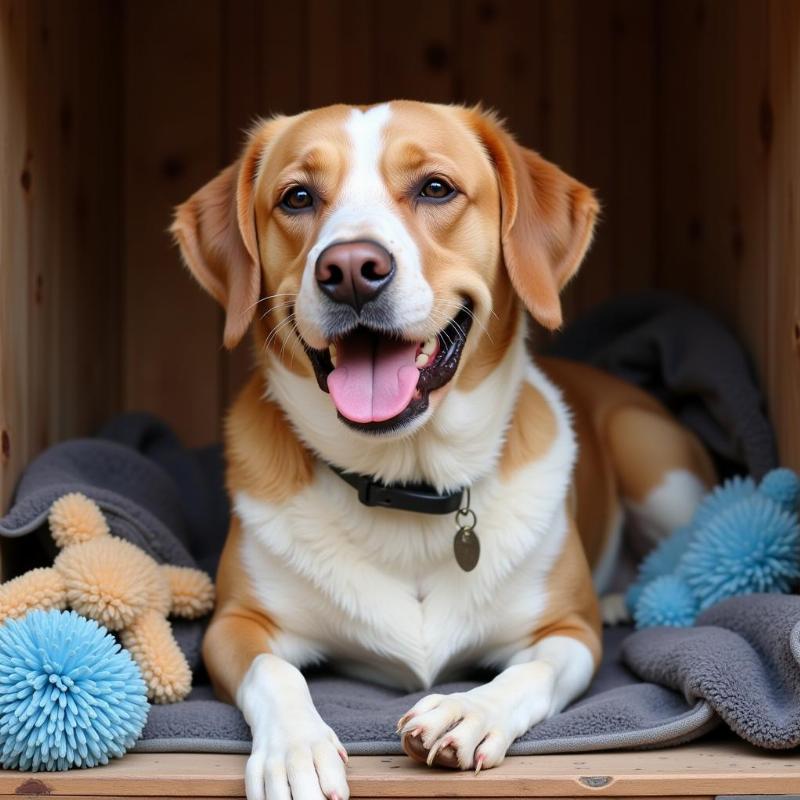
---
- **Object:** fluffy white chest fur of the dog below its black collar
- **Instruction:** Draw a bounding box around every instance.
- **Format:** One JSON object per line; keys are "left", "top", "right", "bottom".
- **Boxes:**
{"left": 235, "top": 365, "right": 575, "bottom": 689}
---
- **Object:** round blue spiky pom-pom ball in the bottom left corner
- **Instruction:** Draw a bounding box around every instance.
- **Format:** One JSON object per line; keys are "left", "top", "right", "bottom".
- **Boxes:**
{"left": 0, "top": 611, "right": 148, "bottom": 772}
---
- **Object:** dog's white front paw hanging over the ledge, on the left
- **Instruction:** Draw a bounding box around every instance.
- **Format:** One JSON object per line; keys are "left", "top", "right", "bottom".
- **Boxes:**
{"left": 245, "top": 712, "right": 350, "bottom": 800}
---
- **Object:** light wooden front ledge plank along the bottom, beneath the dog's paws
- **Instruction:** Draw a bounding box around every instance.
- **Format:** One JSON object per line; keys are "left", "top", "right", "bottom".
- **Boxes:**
{"left": 0, "top": 741, "right": 800, "bottom": 798}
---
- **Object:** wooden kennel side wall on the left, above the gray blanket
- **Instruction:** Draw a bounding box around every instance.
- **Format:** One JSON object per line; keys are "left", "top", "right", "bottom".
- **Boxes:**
{"left": 0, "top": 0, "right": 123, "bottom": 508}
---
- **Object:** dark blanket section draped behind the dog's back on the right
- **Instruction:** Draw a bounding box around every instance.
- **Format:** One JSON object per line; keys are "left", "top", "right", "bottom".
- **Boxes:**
{"left": 550, "top": 292, "right": 778, "bottom": 478}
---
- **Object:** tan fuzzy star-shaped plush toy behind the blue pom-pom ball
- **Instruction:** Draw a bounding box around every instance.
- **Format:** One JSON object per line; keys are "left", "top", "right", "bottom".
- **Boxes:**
{"left": 0, "top": 493, "right": 214, "bottom": 703}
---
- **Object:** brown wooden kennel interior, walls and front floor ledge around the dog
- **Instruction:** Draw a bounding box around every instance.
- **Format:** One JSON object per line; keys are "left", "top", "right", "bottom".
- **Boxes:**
{"left": 0, "top": 0, "right": 800, "bottom": 797}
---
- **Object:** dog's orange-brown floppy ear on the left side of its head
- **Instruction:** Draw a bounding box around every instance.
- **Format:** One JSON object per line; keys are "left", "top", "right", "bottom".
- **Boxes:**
{"left": 170, "top": 127, "right": 264, "bottom": 349}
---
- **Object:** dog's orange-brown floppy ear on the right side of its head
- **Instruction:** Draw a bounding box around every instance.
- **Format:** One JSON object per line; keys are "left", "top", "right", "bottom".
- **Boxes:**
{"left": 472, "top": 111, "right": 600, "bottom": 330}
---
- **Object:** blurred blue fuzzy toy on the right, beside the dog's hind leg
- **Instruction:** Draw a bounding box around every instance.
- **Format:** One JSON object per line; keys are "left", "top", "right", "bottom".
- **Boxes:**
{"left": 626, "top": 469, "right": 800, "bottom": 628}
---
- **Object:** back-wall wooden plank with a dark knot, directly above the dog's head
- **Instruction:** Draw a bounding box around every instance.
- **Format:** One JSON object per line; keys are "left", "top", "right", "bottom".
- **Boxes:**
{"left": 373, "top": 0, "right": 458, "bottom": 103}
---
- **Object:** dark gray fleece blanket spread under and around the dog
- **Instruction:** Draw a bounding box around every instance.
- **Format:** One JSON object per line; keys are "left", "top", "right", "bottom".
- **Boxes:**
{"left": 0, "top": 296, "right": 800, "bottom": 754}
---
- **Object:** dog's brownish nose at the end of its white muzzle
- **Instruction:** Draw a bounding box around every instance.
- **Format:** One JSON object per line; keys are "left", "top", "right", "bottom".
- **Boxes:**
{"left": 314, "top": 242, "right": 394, "bottom": 311}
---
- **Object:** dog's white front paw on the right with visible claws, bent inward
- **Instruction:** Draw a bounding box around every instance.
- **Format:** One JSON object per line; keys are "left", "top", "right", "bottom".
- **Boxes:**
{"left": 397, "top": 689, "right": 517, "bottom": 773}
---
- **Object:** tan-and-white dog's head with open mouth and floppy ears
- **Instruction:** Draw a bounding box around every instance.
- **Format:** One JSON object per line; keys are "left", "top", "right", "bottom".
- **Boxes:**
{"left": 172, "top": 101, "right": 598, "bottom": 434}
